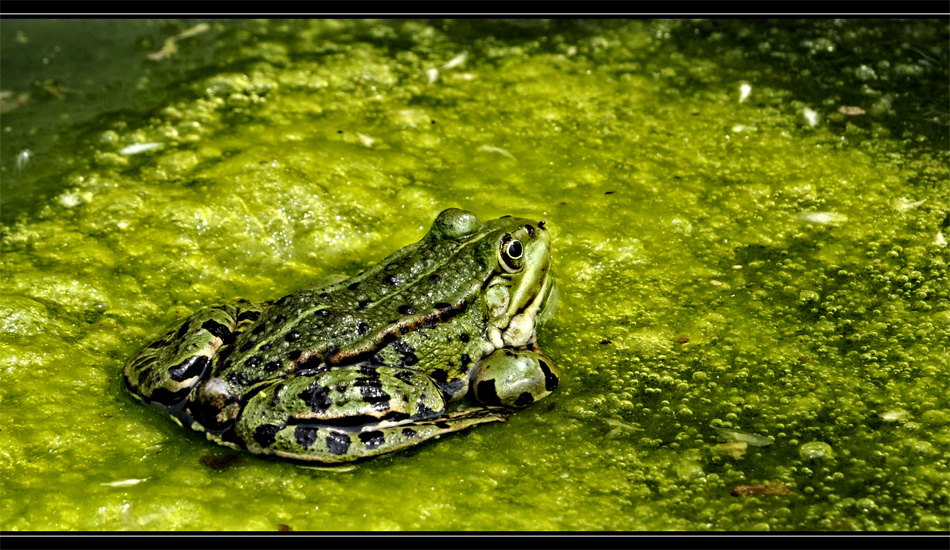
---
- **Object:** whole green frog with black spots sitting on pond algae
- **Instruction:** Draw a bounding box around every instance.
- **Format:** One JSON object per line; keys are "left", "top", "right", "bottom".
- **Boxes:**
{"left": 122, "top": 208, "right": 561, "bottom": 466}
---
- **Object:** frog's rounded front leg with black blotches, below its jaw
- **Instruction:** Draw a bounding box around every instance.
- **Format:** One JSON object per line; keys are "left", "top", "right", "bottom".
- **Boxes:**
{"left": 470, "top": 350, "right": 561, "bottom": 409}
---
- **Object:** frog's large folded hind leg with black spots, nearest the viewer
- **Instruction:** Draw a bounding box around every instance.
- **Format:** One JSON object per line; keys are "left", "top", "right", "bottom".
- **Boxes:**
{"left": 232, "top": 364, "right": 505, "bottom": 464}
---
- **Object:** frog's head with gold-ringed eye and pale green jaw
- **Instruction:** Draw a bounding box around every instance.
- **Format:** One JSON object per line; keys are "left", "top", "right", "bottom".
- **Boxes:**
{"left": 432, "top": 208, "right": 554, "bottom": 349}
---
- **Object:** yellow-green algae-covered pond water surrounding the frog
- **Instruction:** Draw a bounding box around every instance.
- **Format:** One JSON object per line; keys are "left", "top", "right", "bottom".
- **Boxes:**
{"left": 0, "top": 20, "right": 950, "bottom": 531}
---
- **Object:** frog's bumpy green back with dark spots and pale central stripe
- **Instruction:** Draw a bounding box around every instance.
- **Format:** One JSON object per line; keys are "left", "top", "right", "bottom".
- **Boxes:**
{"left": 214, "top": 209, "right": 506, "bottom": 386}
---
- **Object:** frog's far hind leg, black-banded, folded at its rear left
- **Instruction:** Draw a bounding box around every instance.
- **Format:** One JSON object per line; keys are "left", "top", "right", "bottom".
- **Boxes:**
{"left": 123, "top": 300, "right": 261, "bottom": 408}
